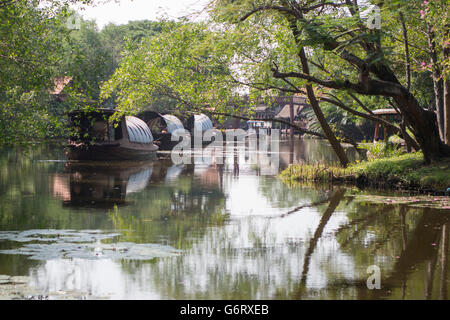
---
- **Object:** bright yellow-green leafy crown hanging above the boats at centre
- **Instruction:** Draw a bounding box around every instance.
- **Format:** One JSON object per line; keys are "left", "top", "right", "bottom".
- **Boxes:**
{"left": 101, "top": 23, "right": 250, "bottom": 119}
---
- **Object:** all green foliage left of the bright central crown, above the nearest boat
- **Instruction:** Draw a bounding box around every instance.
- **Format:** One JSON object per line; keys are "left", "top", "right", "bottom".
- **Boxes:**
{"left": 0, "top": 0, "right": 175, "bottom": 145}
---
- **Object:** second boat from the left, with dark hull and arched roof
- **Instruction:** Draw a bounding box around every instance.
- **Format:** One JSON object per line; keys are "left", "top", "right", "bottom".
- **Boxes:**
{"left": 138, "top": 111, "right": 186, "bottom": 150}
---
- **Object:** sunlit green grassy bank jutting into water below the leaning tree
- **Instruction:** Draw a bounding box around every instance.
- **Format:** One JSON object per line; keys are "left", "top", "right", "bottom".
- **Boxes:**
{"left": 280, "top": 153, "right": 450, "bottom": 194}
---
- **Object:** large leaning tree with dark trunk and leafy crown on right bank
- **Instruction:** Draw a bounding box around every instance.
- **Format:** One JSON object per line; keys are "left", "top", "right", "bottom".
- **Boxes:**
{"left": 211, "top": 0, "right": 450, "bottom": 162}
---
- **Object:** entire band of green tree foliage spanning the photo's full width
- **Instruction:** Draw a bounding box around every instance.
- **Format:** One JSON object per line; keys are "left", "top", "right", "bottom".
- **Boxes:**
{"left": 0, "top": 0, "right": 449, "bottom": 150}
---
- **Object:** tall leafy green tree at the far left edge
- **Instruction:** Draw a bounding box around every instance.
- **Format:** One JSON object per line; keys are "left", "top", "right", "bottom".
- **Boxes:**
{"left": 0, "top": 0, "right": 100, "bottom": 145}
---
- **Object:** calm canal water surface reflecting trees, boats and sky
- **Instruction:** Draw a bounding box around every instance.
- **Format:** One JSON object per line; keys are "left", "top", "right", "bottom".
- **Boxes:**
{"left": 0, "top": 140, "right": 450, "bottom": 299}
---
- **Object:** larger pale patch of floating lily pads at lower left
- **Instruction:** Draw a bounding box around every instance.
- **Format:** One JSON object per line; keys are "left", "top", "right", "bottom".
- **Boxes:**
{"left": 0, "top": 230, "right": 181, "bottom": 260}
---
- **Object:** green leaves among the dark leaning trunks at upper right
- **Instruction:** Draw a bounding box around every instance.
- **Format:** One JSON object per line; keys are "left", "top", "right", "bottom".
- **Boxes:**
{"left": 211, "top": 0, "right": 449, "bottom": 154}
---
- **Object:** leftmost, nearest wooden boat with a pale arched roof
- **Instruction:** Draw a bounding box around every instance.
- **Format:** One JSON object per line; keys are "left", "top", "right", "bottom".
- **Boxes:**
{"left": 67, "top": 109, "right": 158, "bottom": 160}
